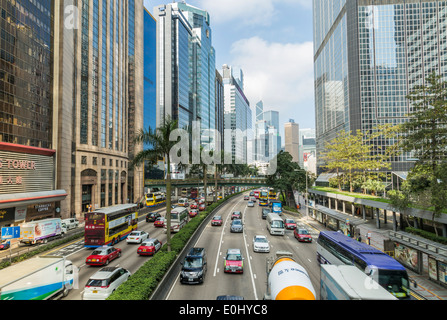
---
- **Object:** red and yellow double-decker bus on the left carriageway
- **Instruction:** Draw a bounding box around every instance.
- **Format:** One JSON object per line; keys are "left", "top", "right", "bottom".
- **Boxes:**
{"left": 84, "top": 203, "right": 138, "bottom": 248}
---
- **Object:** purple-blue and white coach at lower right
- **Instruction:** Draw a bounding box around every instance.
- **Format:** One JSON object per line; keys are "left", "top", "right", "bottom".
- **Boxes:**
{"left": 317, "top": 231, "right": 410, "bottom": 300}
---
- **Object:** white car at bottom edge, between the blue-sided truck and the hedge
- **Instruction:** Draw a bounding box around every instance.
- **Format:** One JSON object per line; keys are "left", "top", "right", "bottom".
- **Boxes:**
{"left": 82, "top": 267, "right": 131, "bottom": 300}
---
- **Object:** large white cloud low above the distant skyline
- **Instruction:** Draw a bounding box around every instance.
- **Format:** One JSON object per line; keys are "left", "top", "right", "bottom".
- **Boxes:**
{"left": 230, "top": 37, "right": 314, "bottom": 126}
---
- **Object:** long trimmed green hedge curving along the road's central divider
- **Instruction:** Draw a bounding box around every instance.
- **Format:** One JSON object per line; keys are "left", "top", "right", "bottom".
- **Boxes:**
{"left": 107, "top": 192, "right": 248, "bottom": 300}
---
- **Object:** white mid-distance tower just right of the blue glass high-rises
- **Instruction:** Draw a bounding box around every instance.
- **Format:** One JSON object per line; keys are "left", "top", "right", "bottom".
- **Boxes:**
{"left": 222, "top": 64, "right": 253, "bottom": 163}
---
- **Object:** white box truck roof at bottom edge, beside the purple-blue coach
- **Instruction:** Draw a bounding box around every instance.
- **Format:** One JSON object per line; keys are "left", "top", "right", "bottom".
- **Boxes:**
{"left": 320, "top": 264, "right": 397, "bottom": 300}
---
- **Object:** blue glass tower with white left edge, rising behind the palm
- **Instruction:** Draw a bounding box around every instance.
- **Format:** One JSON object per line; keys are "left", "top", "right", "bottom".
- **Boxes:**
{"left": 154, "top": 3, "right": 216, "bottom": 149}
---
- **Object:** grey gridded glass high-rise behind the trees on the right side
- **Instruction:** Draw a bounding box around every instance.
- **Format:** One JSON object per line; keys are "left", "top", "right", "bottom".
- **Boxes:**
{"left": 313, "top": 0, "right": 447, "bottom": 173}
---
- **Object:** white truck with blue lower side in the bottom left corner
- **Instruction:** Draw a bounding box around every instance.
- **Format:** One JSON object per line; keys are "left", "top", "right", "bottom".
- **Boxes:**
{"left": 0, "top": 256, "right": 77, "bottom": 300}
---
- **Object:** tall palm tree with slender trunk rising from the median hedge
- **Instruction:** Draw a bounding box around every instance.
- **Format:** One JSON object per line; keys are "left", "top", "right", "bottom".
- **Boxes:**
{"left": 130, "top": 116, "right": 178, "bottom": 251}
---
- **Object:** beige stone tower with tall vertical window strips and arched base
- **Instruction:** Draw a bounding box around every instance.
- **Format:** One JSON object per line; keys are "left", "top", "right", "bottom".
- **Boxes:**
{"left": 54, "top": 0, "right": 144, "bottom": 216}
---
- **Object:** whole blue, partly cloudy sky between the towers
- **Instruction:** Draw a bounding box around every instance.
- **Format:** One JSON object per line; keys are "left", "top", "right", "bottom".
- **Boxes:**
{"left": 144, "top": 0, "right": 315, "bottom": 141}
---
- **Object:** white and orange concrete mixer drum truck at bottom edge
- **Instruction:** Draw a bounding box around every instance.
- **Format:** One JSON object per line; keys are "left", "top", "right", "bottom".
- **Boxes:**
{"left": 264, "top": 251, "right": 316, "bottom": 300}
